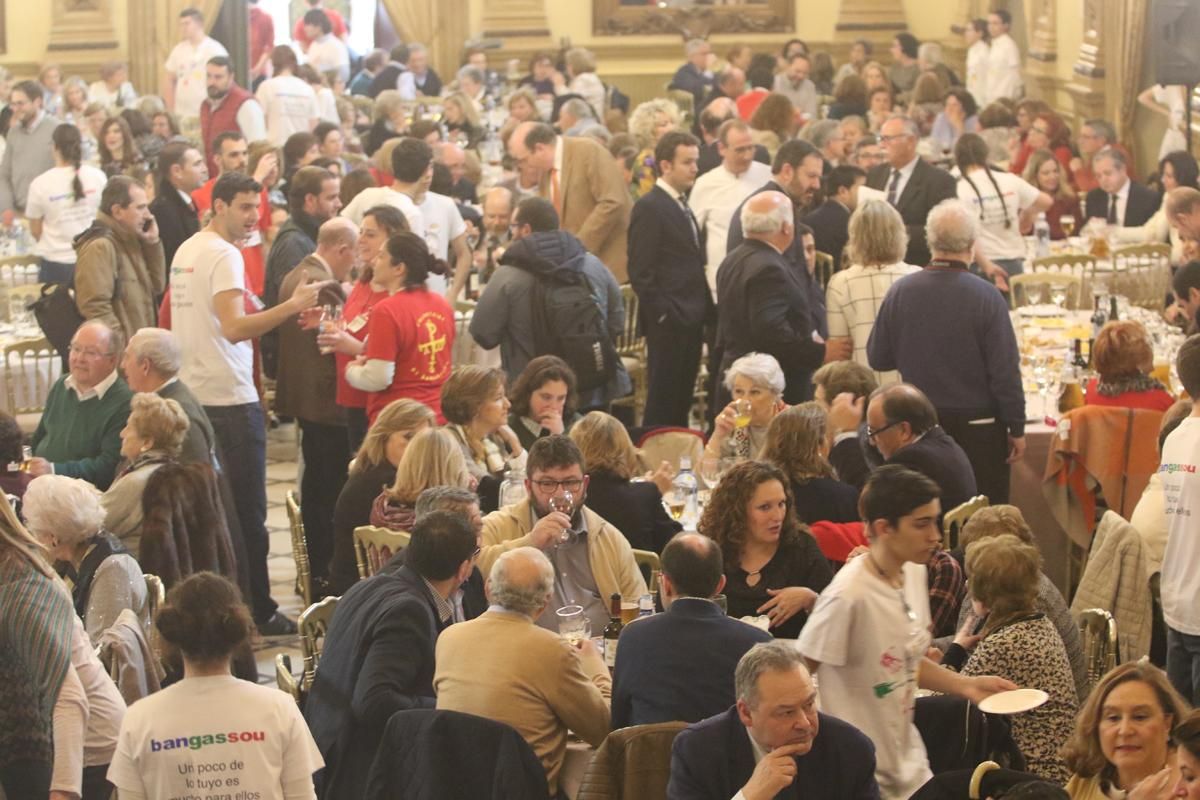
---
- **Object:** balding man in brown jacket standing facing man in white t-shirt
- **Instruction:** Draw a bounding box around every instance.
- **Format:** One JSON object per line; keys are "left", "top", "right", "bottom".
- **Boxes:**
{"left": 275, "top": 217, "right": 359, "bottom": 596}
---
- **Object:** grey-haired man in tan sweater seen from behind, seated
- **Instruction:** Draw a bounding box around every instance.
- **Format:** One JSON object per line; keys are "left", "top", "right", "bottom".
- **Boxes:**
{"left": 433, "top": 547, "right": 612, "bottom": 796}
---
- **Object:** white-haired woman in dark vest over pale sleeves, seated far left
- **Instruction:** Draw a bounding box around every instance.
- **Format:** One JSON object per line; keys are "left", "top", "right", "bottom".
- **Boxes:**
{"left": 22, "top": 475, "right": 150, "bottom": 644}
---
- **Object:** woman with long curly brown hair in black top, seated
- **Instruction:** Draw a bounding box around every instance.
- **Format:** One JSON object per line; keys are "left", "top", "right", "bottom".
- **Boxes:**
{"left": 698, "top": 461, "right": 833, "bottom": 639}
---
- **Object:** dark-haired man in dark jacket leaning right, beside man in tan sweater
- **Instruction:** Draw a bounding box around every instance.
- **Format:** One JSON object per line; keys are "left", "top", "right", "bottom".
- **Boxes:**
{"left": 305, "top": 511, "right": 479, "bottom": 799}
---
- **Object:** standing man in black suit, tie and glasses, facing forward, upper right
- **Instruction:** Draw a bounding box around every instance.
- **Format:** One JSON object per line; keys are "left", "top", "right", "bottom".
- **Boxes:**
{"left": 866, "top": 116, "right": 956, "bottom": 266}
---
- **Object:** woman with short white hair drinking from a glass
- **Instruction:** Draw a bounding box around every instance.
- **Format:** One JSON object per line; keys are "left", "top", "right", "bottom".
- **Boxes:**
{"left": 704, "top": 353, "right": 787, "bottom": 458}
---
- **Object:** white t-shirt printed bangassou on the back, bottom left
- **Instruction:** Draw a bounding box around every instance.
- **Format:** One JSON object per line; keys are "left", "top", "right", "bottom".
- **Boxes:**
{"left": 108, "top": 675, "right": 324, "bottom": 800}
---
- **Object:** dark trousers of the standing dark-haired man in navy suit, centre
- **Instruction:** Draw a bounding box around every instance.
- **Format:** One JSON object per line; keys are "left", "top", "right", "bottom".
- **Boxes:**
{"left": 642, "top": 319, "right": 704, "bottom": 427}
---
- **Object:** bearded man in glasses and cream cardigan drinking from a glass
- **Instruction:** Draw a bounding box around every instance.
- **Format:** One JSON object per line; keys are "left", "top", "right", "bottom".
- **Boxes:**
{"left": 479, "top": 435, "right": 647, "bottom": 633}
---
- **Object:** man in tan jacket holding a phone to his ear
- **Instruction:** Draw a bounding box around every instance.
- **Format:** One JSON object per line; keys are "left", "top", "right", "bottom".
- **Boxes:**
{"left": 74, "top": 175, "right": 167, "bottom": 339}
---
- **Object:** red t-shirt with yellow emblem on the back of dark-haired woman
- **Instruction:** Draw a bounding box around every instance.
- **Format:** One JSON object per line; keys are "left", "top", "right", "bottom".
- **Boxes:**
{"left": 366, "top": 288, "right": 455, "bottom": 425}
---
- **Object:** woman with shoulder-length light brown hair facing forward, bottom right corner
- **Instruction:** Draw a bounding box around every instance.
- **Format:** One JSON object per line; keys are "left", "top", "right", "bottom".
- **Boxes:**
{"left": 1062, "top": 661, "right": 1190, "bottom": 800}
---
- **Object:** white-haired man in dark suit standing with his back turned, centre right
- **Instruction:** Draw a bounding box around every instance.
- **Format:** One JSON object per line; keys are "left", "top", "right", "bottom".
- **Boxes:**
{"left": 715, "top": 190, "right": 850, "bottom": 408}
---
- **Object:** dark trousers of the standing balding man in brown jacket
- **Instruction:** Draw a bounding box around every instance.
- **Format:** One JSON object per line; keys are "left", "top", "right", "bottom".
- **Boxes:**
{"left": 296, "top": 419, "right": 350, "bottom": 578}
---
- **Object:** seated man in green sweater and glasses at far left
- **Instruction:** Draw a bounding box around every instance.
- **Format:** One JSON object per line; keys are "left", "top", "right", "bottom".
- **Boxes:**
{"left": 28, "top": 319, "right": 133, "bottom": 491}
